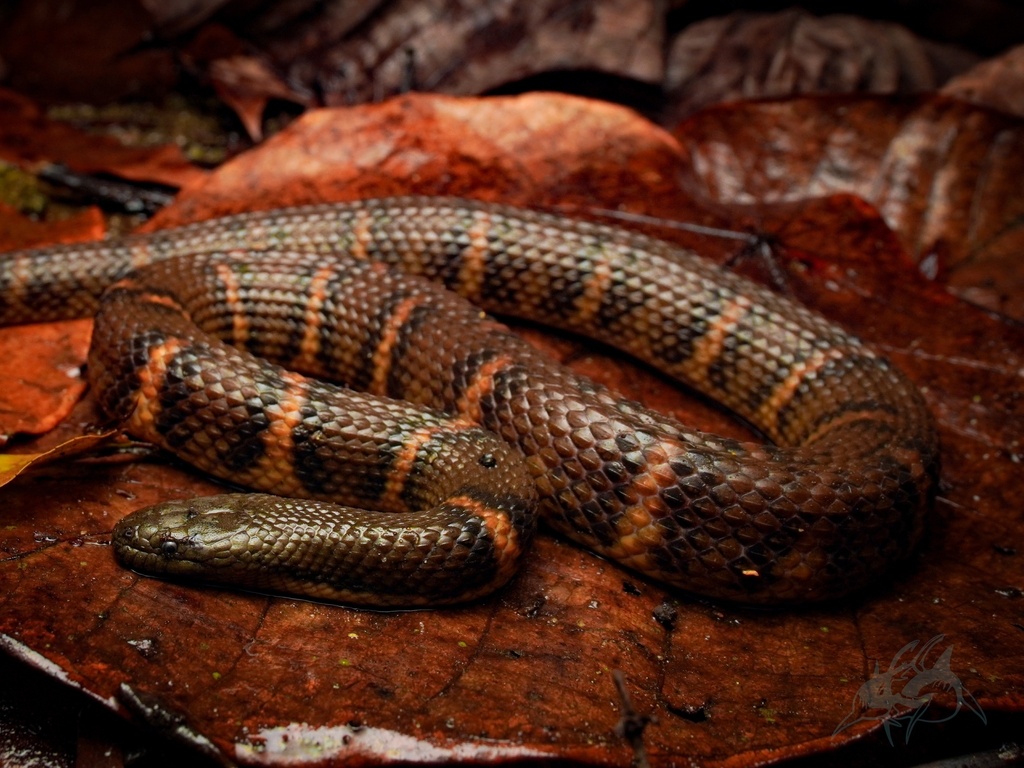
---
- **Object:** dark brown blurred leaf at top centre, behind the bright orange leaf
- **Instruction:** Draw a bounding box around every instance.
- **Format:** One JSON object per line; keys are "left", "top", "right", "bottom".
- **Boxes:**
{"left": 172, "top": 0, "right": 666, "bottom": 104}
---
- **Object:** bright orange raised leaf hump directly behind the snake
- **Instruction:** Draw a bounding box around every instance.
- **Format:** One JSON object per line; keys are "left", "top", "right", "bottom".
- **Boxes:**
{"left": 145, "top": 94, "right": 679, "bottom": 229}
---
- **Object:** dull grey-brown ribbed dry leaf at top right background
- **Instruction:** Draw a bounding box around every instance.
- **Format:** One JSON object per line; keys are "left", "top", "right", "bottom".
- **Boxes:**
{"left": 664, "top": 8, "right": 977, "bottom": 124}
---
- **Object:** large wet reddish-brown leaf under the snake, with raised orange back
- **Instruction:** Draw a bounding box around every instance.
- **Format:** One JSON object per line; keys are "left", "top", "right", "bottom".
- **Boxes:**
{"left": 0, "top": 95, "right": 1024, "bottom": 766}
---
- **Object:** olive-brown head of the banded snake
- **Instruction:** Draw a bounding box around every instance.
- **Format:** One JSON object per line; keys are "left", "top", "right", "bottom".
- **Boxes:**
{"left": 112, "top": 495, "right": 256, "bottom": 579}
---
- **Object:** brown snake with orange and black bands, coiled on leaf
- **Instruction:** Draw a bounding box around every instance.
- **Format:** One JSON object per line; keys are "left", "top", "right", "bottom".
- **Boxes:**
{"left": 0, "top": 197, "right": 938, "bottom": 607}
